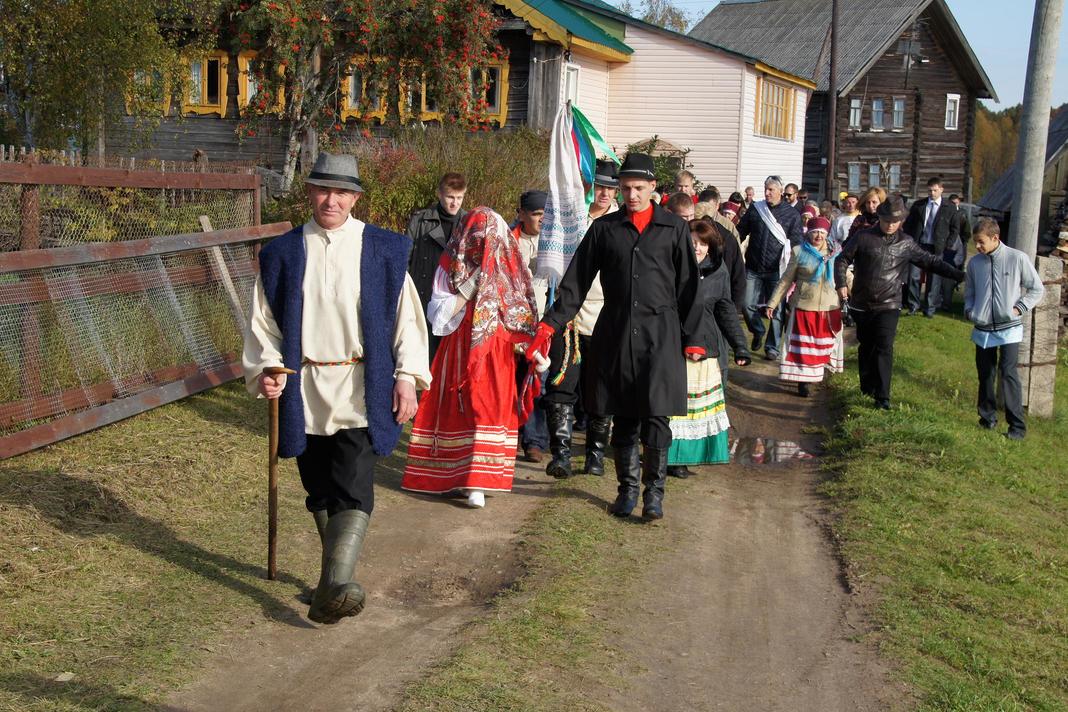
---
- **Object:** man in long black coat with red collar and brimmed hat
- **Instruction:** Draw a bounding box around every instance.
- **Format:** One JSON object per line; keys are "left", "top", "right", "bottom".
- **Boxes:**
{"left": 527, "top": 154, "right": 704, "bottom": 520}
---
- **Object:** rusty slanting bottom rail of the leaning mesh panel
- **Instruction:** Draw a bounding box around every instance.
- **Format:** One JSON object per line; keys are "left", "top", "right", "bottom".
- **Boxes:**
{"left": 0, "top": 361, "right": 242, "bottom": 459}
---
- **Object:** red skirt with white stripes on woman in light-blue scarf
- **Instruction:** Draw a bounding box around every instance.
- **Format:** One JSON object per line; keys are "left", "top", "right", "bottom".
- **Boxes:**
{"left": 779, "top": 308, "right": 845, "bottom": 383}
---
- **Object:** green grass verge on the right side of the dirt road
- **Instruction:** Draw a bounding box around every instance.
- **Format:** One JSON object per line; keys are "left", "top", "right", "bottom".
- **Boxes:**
{"left": 824, "top": 317, "right": 1068, "bottom": 712}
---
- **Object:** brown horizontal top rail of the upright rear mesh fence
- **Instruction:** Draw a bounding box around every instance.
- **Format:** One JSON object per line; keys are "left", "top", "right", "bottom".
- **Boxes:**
{"left": 0, "top": 163, "right": 260, "bottom": 190}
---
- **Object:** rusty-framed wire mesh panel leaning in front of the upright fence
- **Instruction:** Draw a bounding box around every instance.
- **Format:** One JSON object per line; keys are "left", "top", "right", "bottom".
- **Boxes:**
{"left": 0, "top": 223, "right": 289, "bottom": 457}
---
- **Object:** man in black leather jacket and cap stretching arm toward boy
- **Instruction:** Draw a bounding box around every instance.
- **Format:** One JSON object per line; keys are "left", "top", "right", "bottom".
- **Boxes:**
{"left": 834, "top": 195, "right": 964, "bottom": 410}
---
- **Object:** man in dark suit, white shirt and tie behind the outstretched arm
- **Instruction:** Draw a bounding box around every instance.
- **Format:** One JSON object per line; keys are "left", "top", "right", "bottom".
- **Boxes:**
{"left": 904, "top": 177, "right": 960, "bottom": 318}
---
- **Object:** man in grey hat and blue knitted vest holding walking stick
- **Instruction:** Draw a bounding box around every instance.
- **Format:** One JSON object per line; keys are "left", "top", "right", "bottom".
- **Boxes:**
{"left": 242, "top": 153, "right": 430, "bottom": 623}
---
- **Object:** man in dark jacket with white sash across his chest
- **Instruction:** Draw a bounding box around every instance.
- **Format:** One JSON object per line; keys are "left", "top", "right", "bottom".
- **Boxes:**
{"left": 738, "top": 175, "right": 804, "bottom": 361}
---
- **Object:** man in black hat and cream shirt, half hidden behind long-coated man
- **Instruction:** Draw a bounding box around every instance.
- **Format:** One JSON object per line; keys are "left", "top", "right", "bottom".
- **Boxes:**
{"left": 541, "top": 160, "right": 619, "bottom": 478}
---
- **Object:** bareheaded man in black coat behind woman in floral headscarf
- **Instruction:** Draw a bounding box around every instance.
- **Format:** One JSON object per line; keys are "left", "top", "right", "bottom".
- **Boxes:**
{"left": 408, "top": 173, "right": 467, "bottom": 362}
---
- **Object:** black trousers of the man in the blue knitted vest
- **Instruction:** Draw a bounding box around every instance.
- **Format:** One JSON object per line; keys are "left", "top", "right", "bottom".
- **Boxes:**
{"left": 297, "top": 428, "right": 378, "bottom": 515}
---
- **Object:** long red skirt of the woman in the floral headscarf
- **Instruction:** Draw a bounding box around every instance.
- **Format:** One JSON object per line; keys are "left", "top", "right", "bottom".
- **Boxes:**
{"left": 401, "top": 311, "right": 519, "bottom": 493}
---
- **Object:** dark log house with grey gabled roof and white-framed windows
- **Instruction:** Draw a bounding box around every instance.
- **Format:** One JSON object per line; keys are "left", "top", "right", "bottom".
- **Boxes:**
{"left": 690, "top": 0, "right": 996, "bottom": 201}
